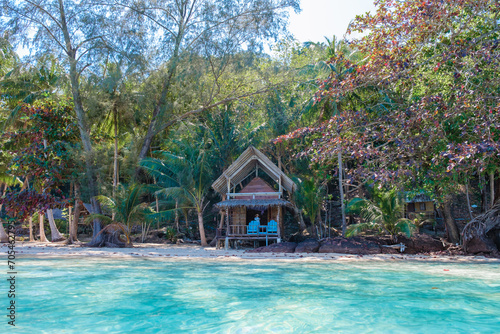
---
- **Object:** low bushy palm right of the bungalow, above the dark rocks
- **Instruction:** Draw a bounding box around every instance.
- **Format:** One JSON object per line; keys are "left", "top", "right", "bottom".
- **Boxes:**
{"left": 346, "top": 188, "right": 416, "bottom": 239}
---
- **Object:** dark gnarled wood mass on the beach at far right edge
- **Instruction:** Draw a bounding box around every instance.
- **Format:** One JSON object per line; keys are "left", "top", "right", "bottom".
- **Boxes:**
{"left": 462, "top": 202, "right": 500, "bottom": 256}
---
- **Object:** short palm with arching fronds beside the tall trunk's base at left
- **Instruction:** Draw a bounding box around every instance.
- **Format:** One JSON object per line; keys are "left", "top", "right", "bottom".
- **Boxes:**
{"left": 85, "top": 185, "right": 154, "bottom": 246}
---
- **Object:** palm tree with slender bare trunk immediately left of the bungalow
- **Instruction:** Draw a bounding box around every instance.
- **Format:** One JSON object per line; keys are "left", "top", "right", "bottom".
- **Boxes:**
{"left": 140, "top": 143, "right": 213, "bottom": 246}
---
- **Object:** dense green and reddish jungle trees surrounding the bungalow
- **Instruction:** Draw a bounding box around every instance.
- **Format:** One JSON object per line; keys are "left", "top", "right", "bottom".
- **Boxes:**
{"left": 0, "top": 0, "right": 500, "bottom": 250}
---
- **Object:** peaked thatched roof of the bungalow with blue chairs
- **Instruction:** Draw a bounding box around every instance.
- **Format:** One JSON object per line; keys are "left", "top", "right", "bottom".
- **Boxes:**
{"left": 212, "top": 146, "right": 297, "bottom": 195}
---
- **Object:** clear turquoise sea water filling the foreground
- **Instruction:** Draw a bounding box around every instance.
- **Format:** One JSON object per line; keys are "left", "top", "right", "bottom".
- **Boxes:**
{"left": 0, "top": 258, "right": 500, "bottom": 333}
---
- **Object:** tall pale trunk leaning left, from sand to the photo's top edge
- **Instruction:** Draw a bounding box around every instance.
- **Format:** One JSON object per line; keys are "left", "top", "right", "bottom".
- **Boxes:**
{"left": 58, "top": 0, "right": 104, "bottom": 246}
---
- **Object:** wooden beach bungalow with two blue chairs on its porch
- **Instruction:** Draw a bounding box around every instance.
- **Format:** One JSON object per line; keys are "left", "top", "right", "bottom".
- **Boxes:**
{"left": 212, "top": 146, "right": 297, "bottom": 248}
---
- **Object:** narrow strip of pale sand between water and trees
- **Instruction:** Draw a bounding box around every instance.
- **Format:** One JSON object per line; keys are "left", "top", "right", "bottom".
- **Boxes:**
{"left": 0, "top": 242, "right": 500, "bottom": 263}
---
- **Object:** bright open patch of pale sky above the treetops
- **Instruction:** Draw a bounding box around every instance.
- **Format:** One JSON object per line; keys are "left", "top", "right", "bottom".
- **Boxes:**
{"left": 289, "top": 0, "right": 375, "bottom": 42}
